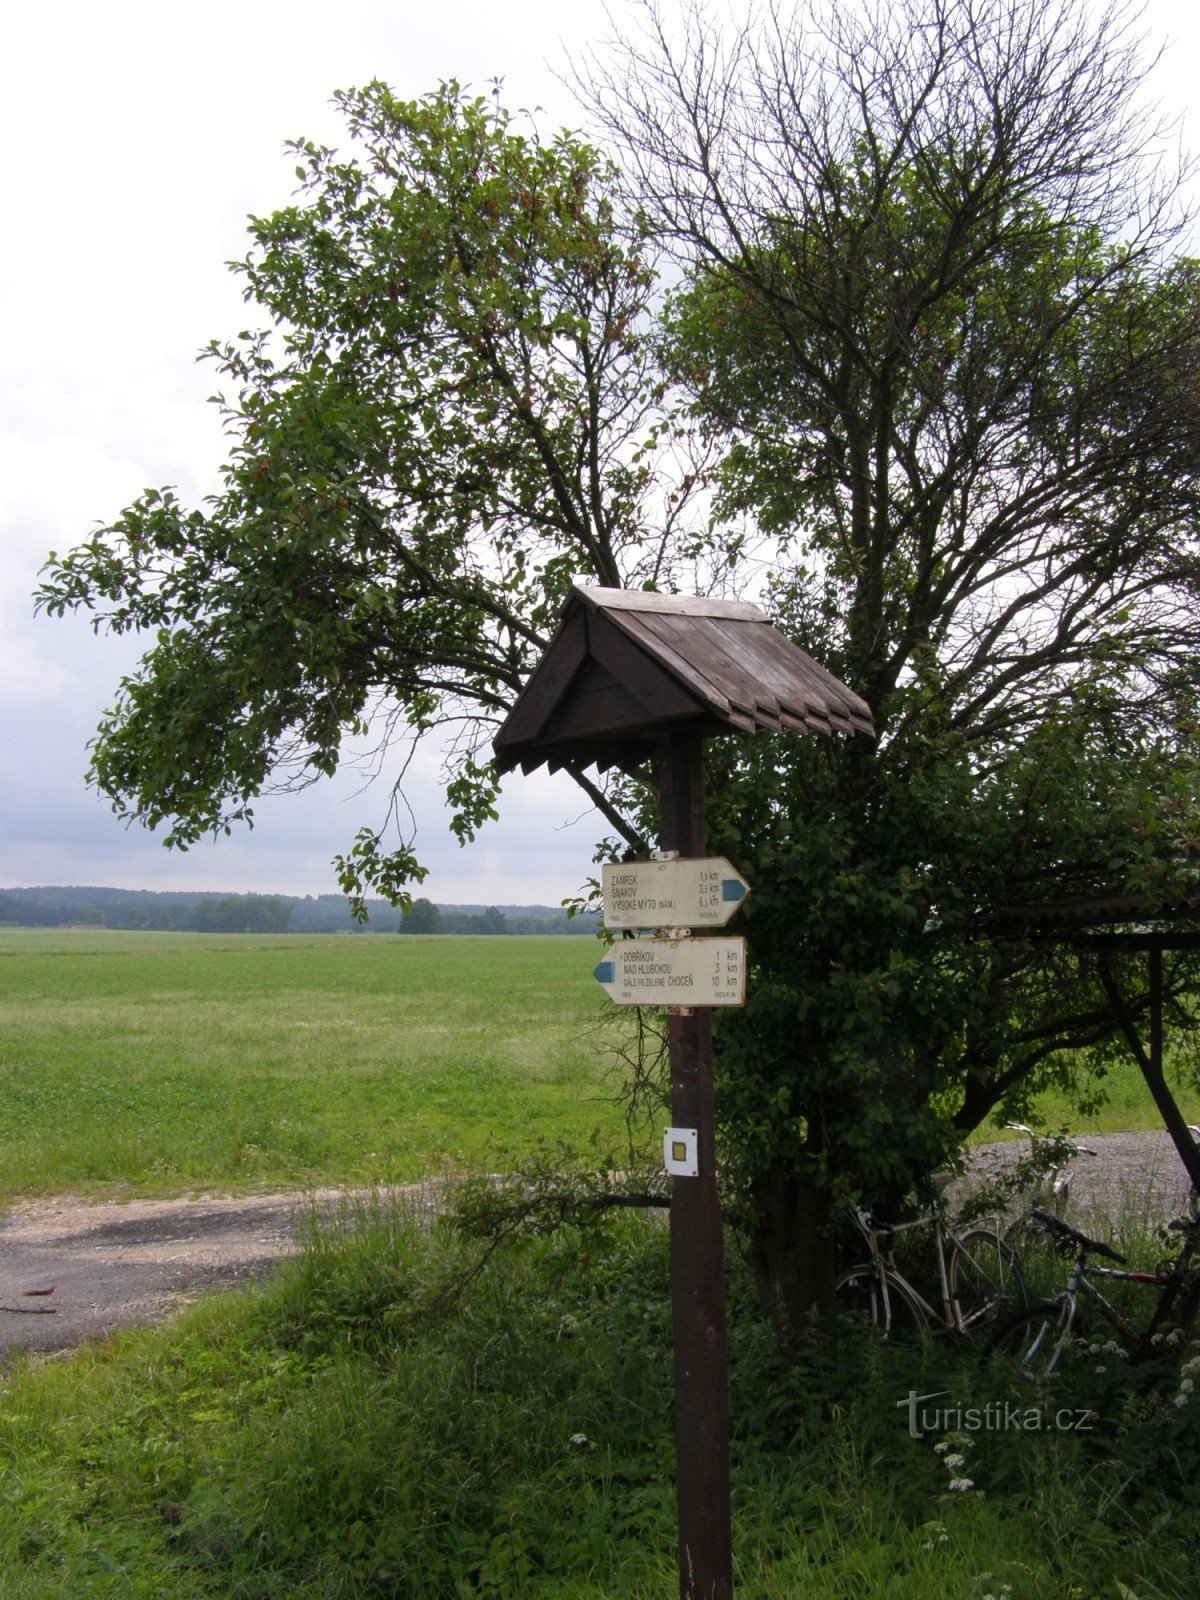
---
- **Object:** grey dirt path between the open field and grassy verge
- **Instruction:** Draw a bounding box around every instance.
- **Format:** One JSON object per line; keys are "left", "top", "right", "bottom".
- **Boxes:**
{"left": 0, "top": 1133, "right": 1187, "bottom": 1354}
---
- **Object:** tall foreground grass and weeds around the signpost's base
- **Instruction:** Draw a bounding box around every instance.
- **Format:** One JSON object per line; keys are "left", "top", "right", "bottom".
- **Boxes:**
{"left": 0, "top": 1198, "right": 1200, "bottom": 1600}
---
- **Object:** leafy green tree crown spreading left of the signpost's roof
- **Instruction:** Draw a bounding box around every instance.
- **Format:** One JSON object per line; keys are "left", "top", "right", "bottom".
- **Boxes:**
{"left": 40, "top": 83, "right": 694, "bottom": 883}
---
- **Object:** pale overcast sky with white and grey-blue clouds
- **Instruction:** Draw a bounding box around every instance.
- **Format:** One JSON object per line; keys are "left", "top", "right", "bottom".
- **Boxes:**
{"left": 0, "top": 0, "right": 1200, "bottom": 902}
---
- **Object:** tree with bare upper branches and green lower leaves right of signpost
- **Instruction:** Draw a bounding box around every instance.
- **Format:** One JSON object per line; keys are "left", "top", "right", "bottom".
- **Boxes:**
{"left": 592, "top": 0, "right": 1200, "bottom": 1315}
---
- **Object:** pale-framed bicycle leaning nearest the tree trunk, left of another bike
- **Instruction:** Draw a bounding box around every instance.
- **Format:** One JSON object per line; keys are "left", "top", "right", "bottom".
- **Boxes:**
{"left": 835, "top": 1202, "right": 1029, "bottom": 1338}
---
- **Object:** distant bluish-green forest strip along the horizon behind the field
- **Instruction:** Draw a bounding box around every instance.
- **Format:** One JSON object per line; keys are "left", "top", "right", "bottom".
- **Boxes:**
{"left": 0, "top": 886, "right": 597, "bottom": 934}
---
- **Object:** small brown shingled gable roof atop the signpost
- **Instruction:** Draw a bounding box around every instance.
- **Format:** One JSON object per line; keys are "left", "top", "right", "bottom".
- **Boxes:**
{"left": 493, "top": 587, "right": 875, "bottom": 773}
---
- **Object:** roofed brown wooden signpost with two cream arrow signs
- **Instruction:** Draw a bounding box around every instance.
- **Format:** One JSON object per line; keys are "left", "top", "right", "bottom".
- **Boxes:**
{"left": 494, "top": 589, "right": 874, "bottom": 1600}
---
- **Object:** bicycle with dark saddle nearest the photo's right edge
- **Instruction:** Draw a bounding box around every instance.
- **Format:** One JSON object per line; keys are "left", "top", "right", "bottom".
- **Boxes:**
{"left": 989, "top": 1211, "right": 1200, "bottom": 1378}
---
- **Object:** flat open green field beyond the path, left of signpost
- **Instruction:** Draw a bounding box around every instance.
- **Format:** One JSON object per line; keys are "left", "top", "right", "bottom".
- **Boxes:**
{"left": 0, "top": 930, "right": 622, "bottom": 1197}
